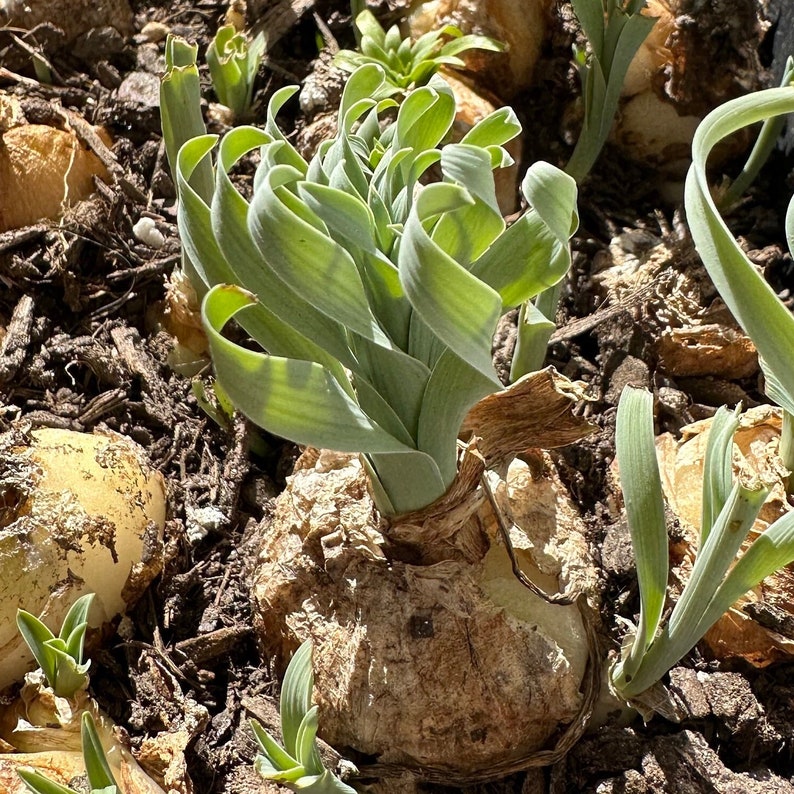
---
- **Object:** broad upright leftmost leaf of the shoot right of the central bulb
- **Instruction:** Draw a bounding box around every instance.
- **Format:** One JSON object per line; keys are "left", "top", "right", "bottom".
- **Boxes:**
{"left": 615, "top": 386, "right": 668, "bottom": 680}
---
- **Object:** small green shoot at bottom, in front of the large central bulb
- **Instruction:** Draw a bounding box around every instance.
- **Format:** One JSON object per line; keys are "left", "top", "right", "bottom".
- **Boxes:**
{"left": 251, "top": 641, "right": 355, "bottom": 794}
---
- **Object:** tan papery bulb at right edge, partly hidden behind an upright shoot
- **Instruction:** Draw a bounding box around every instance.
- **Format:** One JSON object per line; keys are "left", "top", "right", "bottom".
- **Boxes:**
{"left": 657, "top": 405, "right": 794, "bottom": 667}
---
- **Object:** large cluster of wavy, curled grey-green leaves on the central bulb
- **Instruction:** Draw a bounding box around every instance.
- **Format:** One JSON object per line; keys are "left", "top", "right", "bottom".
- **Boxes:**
{"left": 176, "top": 64, "right": 578, "bottom": 515}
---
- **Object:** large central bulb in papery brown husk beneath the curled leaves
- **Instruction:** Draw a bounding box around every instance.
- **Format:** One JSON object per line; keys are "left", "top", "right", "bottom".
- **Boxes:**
{"left": 248, "top": 371, "right": 593, "bottom": 785}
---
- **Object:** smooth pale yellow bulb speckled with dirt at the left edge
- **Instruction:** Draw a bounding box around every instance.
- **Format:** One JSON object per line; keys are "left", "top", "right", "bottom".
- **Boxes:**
{"left": 0, "top": 428, "right": 165, "bottom": 689}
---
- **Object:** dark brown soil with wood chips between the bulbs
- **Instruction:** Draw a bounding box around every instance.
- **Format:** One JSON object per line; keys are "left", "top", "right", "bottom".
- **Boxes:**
{"left": 0, "top": 0, "right": 794, "bottom": 794}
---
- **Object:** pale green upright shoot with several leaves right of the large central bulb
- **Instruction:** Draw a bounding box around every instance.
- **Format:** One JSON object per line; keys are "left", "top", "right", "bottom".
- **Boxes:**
{"left": 610, "top": 386, "right": 794, "bottom": 701}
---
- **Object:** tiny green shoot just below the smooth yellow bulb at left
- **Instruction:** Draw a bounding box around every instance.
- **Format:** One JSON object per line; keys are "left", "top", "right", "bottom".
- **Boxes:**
{"left": 17, "top": 593, "right": 94, "bottom": 698}
